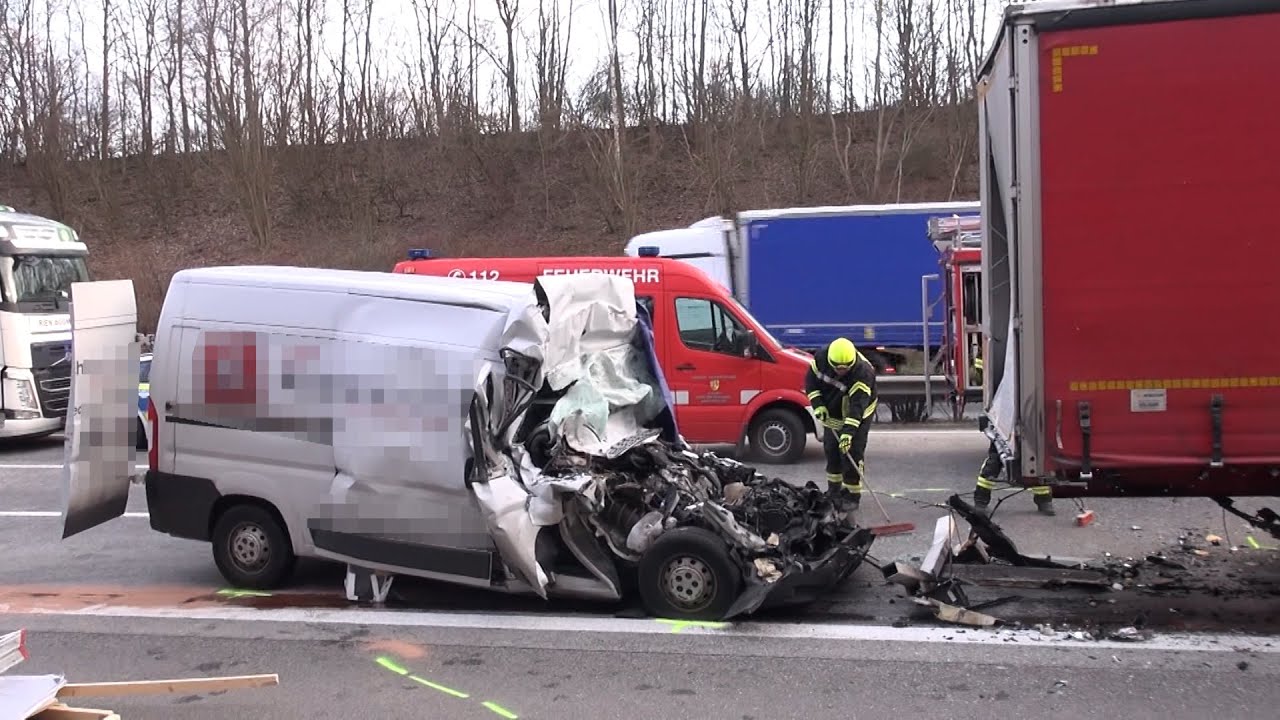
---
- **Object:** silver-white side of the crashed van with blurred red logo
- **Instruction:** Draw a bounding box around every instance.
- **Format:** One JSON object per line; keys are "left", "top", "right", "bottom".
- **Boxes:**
{"left": 148, "top": 283, "right": 506, "bottom": 584}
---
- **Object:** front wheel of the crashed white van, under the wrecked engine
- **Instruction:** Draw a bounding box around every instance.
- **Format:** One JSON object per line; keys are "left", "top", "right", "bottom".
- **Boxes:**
{"left": 639, "top": 528, "right": 742, "bottom": 620}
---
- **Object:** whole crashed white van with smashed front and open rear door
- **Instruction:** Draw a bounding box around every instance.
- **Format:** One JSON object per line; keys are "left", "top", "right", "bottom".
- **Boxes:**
{"left": 65, "top": 266, "right": 872, "bottom": 619}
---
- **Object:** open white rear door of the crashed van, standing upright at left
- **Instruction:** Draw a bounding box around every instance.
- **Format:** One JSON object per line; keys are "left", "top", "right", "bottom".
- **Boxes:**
{"left": 63, "top": 281, "right": 140, "bottom": 538}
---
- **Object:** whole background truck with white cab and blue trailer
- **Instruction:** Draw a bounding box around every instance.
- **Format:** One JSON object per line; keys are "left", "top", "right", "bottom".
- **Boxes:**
{"left": 626, "top": 201, "right": 980, "bottom": 398}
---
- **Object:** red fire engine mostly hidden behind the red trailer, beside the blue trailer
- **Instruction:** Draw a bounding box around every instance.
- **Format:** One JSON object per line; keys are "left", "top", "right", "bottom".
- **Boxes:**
{"left": 928, "top": 215, "right": 983, "bottom": 420}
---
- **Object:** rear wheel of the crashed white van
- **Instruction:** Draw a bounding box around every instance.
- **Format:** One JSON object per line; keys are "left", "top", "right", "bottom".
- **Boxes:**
{"left": 212, "top": 503, "right": 297, "bottom": 589}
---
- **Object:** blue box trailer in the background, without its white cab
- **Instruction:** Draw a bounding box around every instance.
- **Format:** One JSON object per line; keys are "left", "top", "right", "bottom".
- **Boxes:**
{"left": 735, "top": 202, "right": 979, "bottom": 350}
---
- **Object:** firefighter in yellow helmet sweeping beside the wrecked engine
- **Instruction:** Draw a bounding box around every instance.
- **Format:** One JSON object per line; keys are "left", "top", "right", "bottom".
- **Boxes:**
{"left": 804, "top": 337, "right": 877, "bottom": 511}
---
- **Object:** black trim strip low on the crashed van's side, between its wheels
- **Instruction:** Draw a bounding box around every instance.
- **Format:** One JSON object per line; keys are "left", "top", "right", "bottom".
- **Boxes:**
{"left": 307, "top": 520, "right": 494, "bottom": 580}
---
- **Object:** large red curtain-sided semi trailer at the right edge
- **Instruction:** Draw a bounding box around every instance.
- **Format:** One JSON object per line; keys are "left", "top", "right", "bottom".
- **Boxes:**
{"left": 978, "top": 0, "right": 1280, "bottom": 532}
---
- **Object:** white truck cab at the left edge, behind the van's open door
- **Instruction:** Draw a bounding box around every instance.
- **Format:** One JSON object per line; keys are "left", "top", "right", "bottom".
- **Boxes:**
{"left": 0, "top": 206, "right": 90, "bottom": 438}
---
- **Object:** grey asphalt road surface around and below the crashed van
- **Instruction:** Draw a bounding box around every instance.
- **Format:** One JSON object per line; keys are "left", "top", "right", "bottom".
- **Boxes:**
{"left": 0, "top": 427, "right": 1280, "bottom": 719}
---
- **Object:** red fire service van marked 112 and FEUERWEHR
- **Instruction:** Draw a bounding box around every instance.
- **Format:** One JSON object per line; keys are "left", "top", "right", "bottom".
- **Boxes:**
{"left": 393, "top": 249, "right": 820, "bottom": 462}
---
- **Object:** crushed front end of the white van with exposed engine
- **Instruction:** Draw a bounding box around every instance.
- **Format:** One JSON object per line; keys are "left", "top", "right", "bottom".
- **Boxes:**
{"left": 468, "top": 275, "right": 874, "bottom": 620}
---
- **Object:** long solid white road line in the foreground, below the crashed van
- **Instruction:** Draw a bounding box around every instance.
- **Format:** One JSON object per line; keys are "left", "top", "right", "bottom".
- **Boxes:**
{"left": 15, "top": 605, "right": 1280, "bottom": 655}
